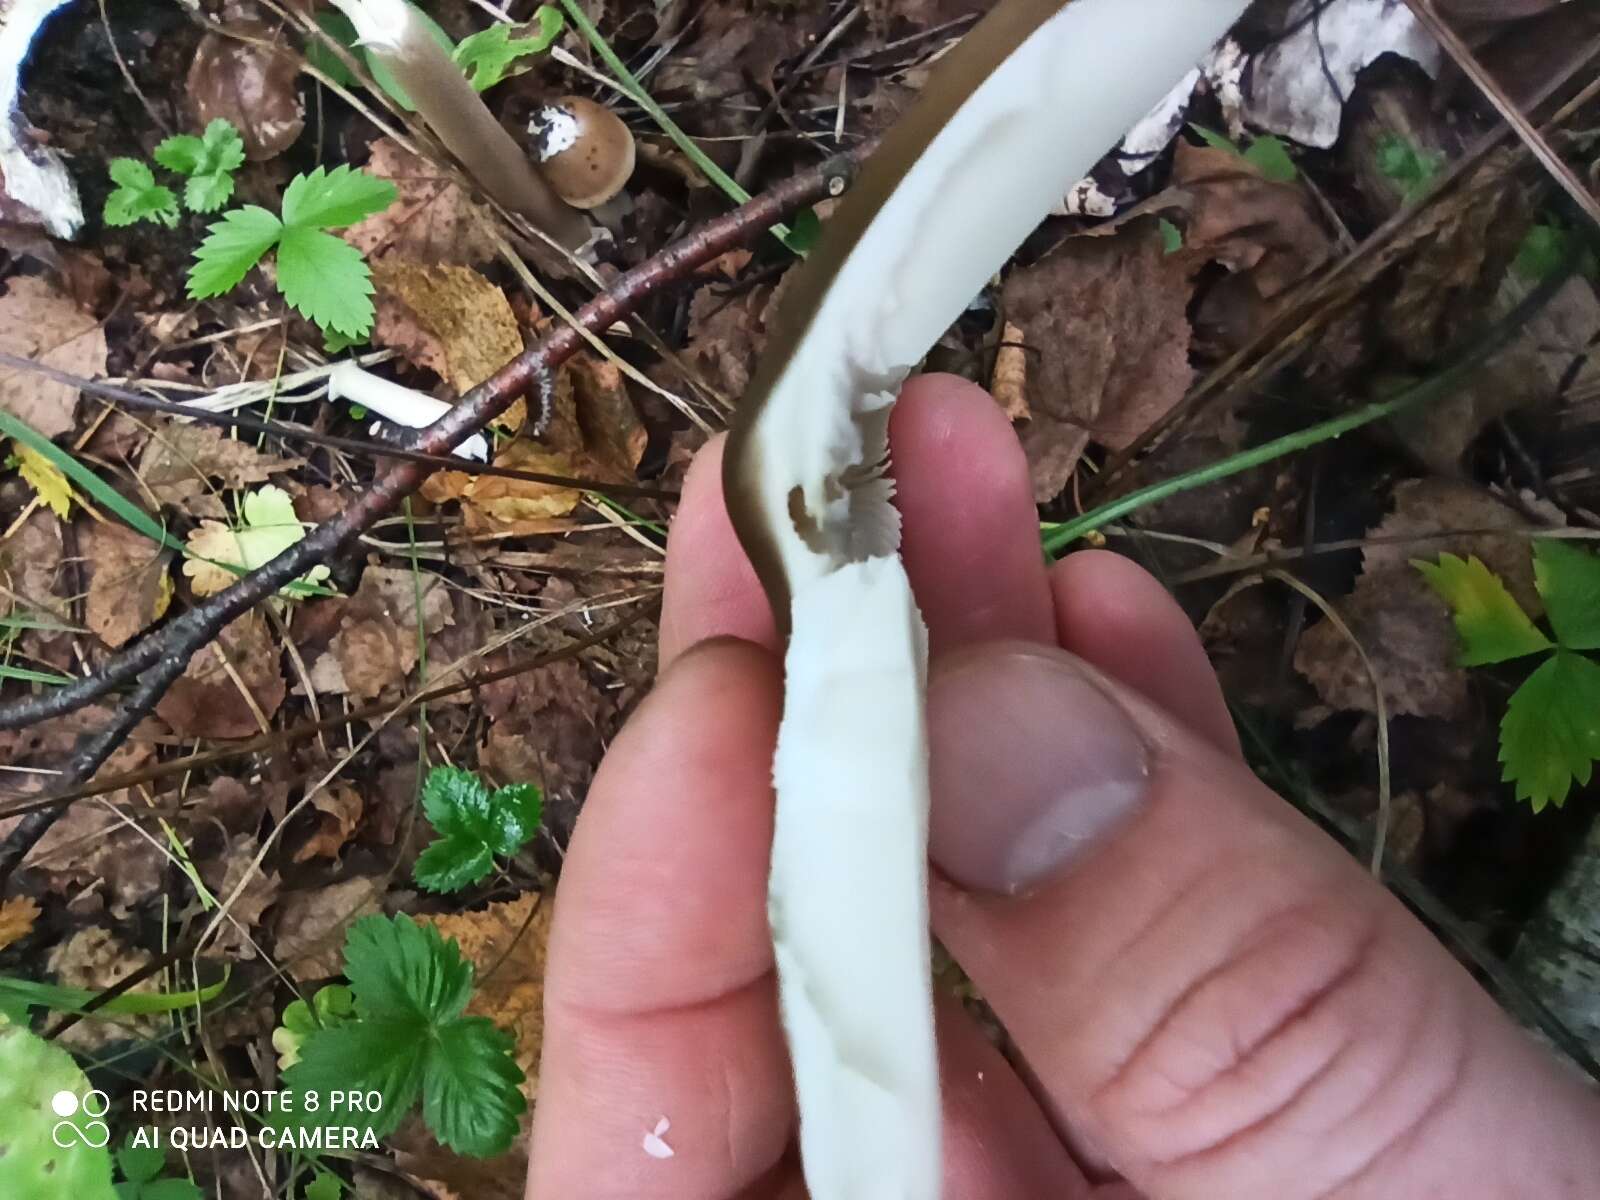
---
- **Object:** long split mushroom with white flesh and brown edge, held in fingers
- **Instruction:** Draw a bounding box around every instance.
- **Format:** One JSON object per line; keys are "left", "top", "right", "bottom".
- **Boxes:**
{"left": 723, "top": 0, "right": 1245, "bottom": 1200}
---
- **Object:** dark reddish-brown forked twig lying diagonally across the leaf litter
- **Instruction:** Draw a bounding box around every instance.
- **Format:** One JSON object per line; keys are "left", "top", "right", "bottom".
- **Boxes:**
{"left": 0, "top": 150, "right": 861, "bottom": 886}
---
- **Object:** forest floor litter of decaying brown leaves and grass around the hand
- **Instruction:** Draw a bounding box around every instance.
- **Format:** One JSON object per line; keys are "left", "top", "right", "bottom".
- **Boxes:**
{"left": 0, "top": 0, "right": 1600, "bottom": 1197}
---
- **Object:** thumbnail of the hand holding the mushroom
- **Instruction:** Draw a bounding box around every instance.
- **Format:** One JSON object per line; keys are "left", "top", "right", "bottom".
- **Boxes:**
{"left": 928, "top": 645, "right": 1150, "bottom": 894}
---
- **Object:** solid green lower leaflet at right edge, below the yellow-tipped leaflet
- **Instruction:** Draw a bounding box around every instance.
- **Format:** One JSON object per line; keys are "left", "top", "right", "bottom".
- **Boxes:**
{"left": 1499, "top": 650, "right": 1600, "bottom": 813}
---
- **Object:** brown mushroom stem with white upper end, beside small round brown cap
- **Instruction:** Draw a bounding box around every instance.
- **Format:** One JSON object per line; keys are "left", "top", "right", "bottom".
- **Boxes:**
{"left": 333, "top": 0, "right": 589, "bottom": 250}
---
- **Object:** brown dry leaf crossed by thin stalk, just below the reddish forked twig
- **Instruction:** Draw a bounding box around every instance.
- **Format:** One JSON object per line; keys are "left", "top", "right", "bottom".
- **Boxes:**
{"left": 155, "top": 611, "right": 286, "bottom": 738}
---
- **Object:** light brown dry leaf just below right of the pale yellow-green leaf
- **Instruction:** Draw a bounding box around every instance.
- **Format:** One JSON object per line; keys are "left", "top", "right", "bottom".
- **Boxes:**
{"left": 312, "top": 566, "right": 454, "bottom": 699}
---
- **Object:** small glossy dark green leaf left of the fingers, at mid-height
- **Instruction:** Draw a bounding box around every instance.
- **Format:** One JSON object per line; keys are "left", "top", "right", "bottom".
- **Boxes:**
{"left": 413, "top": 766, "right": 544, "bottom": 891}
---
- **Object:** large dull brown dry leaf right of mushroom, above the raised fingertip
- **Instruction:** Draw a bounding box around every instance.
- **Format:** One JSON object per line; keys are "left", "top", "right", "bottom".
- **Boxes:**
{"left": 1003, "top": 222, "right": 1194, "bottom": 502}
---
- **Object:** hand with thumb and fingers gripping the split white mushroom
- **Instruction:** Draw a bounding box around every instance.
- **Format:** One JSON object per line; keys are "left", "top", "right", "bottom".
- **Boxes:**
{"left": 528, "top": 376, "right": 1600, "bottom": 1200}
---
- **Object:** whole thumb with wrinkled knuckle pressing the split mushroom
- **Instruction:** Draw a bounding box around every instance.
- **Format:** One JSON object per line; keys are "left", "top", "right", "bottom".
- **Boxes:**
{"left": 930, "top": 643, "right": 1600, "bottom": 1200}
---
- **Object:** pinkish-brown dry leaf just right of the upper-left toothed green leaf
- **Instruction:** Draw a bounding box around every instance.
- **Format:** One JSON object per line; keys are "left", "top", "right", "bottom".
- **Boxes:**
{"left": 344, "top": 138, "right": 496, "bottom": 266}
